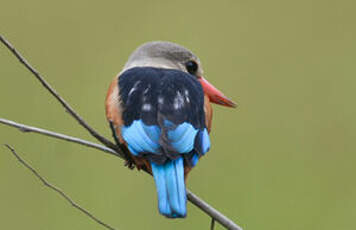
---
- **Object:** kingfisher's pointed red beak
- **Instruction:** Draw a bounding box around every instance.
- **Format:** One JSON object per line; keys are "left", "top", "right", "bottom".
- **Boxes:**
{"left": 198, "top": 77, "right": 236, "bottom": 108}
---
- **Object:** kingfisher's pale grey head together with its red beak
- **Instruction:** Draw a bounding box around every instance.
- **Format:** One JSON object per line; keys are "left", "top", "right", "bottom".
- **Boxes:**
{"left": 124, "top": 41, "right": 236, "bottom": 107}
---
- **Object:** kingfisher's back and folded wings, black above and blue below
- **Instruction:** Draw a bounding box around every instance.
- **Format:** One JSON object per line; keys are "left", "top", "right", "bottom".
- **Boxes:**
{"left": 118, "top": 67, "right": 207, "bottom": 163}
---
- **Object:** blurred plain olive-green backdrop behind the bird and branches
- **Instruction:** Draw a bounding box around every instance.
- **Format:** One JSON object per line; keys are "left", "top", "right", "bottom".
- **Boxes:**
{"left": 0, "top": 0, "right": 356, "bottom": 230}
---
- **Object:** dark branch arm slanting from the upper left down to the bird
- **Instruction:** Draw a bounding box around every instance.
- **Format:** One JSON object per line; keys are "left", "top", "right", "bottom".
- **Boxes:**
{"left": 0, "top": 35, "right": 124, "bottom": 157}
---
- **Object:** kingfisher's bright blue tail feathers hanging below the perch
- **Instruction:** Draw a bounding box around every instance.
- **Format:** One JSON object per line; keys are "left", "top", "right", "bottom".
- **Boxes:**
{"left": 151, "top": 157, "right": 187, "bottom": 218}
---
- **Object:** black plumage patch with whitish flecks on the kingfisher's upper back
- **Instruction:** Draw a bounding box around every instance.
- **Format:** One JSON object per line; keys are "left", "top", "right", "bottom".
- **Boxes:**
{"left": 118, "top": 67, "right": 205, "bottom": 129}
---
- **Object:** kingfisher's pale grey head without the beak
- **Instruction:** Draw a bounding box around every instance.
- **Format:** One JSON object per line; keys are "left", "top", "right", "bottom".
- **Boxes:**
{"left": 123, "top": 41, "right": 203, "bottom": 76}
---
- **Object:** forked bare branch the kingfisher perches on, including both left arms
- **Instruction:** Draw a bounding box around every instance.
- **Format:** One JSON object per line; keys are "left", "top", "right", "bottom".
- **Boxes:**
{"left": 0, "top": 35, "right": 242, "bottom": 230}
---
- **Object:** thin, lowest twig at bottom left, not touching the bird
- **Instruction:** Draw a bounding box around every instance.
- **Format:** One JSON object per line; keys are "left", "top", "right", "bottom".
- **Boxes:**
{"left": 5, "top": 144, "right": 115, "bottom": 230}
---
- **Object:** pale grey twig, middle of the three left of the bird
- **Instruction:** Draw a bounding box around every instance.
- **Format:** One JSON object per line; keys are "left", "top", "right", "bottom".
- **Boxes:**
{"left": 0, "top": 118, "right": 122, "bottom": 158}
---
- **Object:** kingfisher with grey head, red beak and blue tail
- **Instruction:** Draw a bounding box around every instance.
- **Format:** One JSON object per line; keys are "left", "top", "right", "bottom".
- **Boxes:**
{"left": 105, "top": 41, "right": 236, "bottom": 218}
